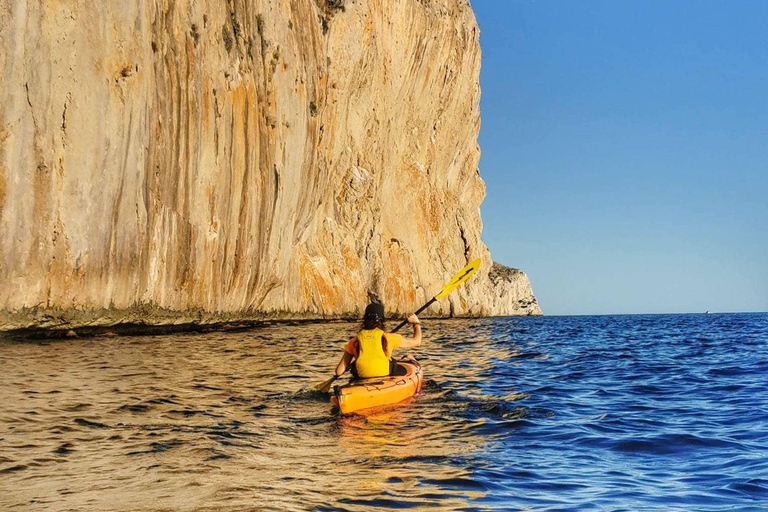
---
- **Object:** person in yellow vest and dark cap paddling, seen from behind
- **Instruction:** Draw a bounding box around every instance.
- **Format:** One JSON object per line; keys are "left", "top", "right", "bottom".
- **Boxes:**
{"left": 336, "top": 303, "right": 421, "bottom": 379}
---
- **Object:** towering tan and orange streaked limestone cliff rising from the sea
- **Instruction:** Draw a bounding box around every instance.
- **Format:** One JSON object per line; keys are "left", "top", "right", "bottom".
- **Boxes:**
{"left": 0, "top": 0, "right": 540, "bottom": 329}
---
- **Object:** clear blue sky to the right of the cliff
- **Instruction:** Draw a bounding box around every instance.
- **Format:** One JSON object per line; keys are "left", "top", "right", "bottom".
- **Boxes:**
{"left": 471, "top": 0, "right": 768, "bottom": 315}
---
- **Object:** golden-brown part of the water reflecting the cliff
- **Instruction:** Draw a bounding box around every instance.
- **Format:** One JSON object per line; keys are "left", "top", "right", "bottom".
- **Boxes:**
{"left": 0, "top": 322, "right": 492, "bottom": 511}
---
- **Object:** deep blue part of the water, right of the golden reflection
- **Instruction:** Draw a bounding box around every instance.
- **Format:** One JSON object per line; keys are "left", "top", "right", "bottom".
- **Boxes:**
{"left": 456, "top": 315, "right": 768, "bottom": 511}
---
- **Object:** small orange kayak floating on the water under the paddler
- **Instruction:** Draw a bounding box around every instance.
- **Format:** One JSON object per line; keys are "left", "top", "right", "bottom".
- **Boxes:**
{"left": 331, "top": 358, "right": 422, "bottom": 414}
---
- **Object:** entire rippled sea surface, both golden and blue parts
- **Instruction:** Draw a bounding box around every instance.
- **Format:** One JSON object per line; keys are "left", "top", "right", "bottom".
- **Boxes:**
{"left": 0, "top": 313, "right": 768, "bottom": 512}
